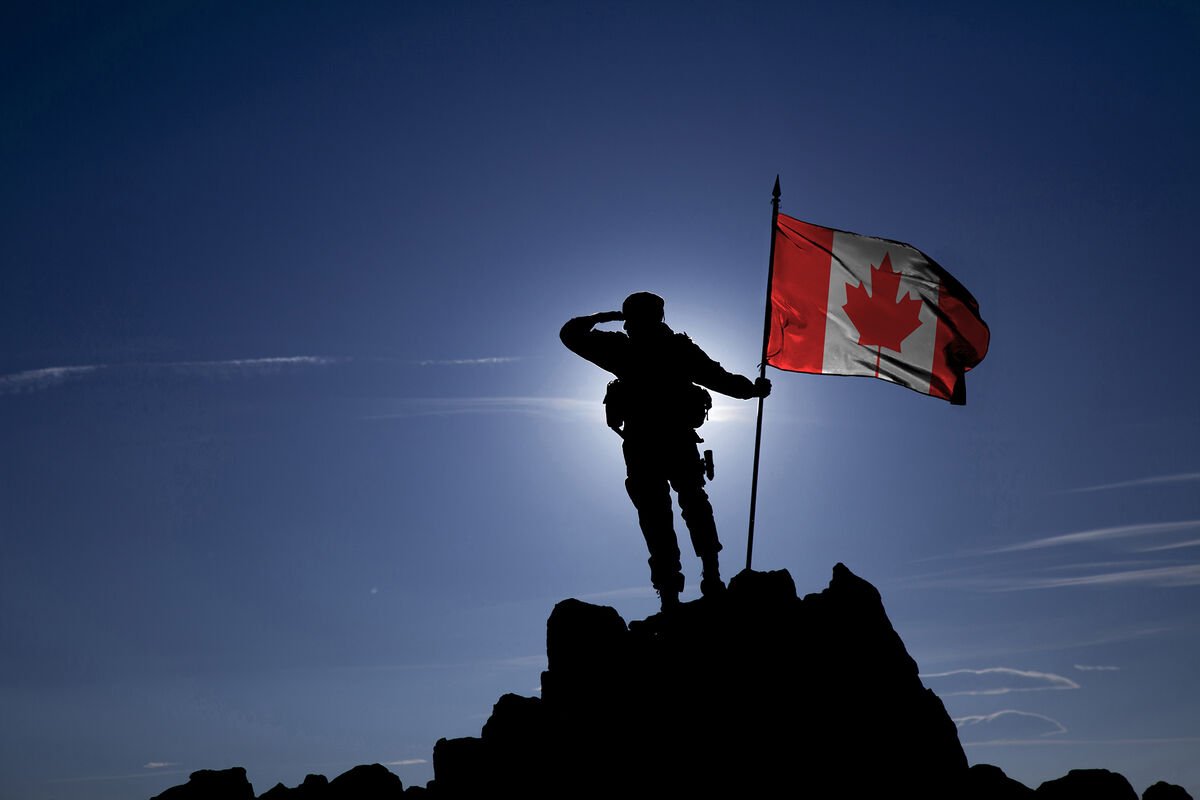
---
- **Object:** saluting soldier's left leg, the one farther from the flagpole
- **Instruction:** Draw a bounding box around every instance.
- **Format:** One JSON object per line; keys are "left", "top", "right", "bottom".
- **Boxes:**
{"left": 623, "top": 441, "right": 683, "bottom": 604}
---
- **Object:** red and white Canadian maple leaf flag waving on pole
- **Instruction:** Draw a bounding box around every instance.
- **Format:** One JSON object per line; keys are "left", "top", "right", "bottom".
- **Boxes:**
{"left": 767, "top": 213, "right": 990, "bottom": 405}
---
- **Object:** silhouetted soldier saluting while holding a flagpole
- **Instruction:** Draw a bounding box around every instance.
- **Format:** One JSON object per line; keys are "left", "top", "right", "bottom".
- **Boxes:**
{"left": 559, "top": 291, "right": 770, "bottom": 610}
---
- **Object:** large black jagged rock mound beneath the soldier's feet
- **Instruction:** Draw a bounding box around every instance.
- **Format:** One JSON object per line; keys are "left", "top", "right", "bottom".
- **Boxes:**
{"left": 428, "top": 564, "right": 967, "bottom": 798}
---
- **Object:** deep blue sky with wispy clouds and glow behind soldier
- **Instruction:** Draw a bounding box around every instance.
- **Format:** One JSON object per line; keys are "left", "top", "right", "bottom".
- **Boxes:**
{"left": 0, "top": 0, "right": 1200, "bottom": 800}
